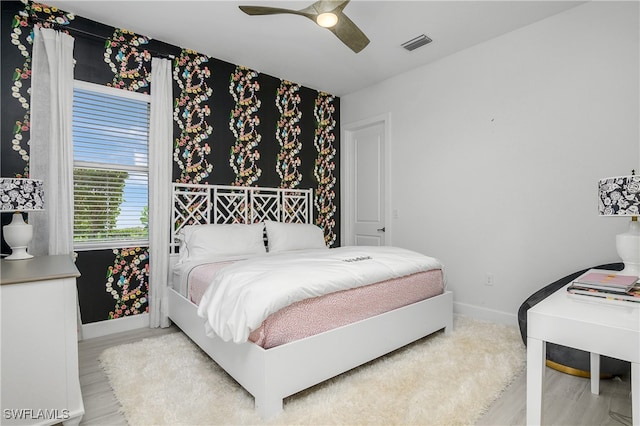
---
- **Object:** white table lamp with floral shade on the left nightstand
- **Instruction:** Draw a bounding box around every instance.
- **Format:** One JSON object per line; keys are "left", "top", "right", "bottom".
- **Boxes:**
{"left": 0, "top": 178, "right": 44, "bottom": 260}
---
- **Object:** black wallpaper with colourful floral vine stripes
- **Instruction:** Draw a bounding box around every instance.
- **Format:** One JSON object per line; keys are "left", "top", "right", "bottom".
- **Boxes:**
{"left": 0, "top": 0, "right": 340, "bottom": 324}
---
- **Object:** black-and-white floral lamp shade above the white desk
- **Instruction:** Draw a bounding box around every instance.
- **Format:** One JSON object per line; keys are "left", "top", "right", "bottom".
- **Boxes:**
{"left": 598, "top": 175, "right": 640, "bottom": 216}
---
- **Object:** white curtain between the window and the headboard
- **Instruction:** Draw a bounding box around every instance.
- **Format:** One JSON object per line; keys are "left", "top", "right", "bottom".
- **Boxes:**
{"left": 149, "top": 58, "right": 173, "bottom": 328}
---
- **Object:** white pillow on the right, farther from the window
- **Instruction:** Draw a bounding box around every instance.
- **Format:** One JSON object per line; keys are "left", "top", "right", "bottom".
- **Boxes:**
{"left": 265, "top": 220, "right": 327, "bottom": 253}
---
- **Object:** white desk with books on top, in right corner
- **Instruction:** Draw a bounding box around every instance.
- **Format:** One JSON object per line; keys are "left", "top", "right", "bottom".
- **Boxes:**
{"left": 527, "top": 286, "right": 640, "bottom": 426}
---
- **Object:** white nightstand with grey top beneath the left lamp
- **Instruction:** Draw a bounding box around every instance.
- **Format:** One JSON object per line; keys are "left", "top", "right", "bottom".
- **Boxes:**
{"left": 0, "top": 256, "right": 84, "bottom": 425}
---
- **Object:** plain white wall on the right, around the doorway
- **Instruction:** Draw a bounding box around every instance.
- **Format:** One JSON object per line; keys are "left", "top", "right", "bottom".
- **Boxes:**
{"left": 341, "top": 2, "right": 640, "bottom": 322}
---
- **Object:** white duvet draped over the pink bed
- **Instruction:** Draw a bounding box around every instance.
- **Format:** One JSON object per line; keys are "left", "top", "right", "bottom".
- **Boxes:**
{"left": 198, "top": 246, "right": 442, "bottom": 343}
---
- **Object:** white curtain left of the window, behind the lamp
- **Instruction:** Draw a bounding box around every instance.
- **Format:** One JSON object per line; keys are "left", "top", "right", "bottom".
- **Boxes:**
{"left": 29, "top": 26, "right": 74, "bottom": 256}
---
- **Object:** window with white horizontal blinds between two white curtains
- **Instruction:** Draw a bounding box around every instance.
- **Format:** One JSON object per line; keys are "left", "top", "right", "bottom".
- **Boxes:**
{"left": 73, "top": 81, "right": 150, "bottom": 249}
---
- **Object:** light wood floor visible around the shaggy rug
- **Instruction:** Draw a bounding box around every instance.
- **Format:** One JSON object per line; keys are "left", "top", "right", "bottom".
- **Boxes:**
{"left": 79, "top": 327, "right": 638, "bottom": 426}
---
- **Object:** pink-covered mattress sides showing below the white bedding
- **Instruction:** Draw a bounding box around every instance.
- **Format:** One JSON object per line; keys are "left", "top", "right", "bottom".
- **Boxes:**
{"left": 187, "top": 261, "right": 444, "bottom": 349}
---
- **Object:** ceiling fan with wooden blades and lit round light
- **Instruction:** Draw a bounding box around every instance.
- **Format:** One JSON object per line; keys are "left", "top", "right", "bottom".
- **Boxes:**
{"left": 238, "top": 0, "right": 369, "bottom": 53}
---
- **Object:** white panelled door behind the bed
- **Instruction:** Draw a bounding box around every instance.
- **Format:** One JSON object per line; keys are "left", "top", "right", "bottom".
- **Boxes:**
{"left": 345, "top": 121, "right": 387, "bottom": 246}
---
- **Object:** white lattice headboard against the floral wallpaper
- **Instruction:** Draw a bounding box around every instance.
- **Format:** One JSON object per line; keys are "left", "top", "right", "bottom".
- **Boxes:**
{"left": 170, "top": 183, "right": 313, "bottom": 254}
